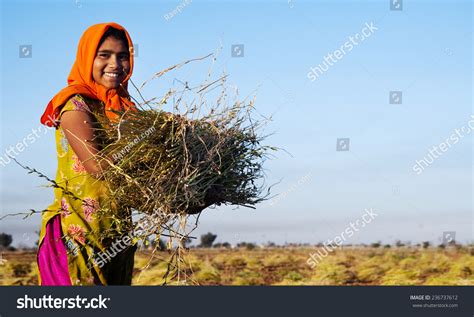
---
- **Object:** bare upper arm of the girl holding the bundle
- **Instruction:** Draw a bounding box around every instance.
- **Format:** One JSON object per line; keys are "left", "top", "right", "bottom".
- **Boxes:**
{"left": 60, "top": 111, "right": 109, "bottom": 178}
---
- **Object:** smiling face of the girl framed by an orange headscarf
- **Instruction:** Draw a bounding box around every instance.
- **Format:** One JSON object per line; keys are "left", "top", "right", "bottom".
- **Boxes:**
{"left": 92, "top": 36, "right": 130, "bottom": 89}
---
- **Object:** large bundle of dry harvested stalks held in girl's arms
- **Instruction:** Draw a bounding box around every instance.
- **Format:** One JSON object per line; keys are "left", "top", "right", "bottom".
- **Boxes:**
{"left": 95, "top": 99, "right": 269, "bottom": 215}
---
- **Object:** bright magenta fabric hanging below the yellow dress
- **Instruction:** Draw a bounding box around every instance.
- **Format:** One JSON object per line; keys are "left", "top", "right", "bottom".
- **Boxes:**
{"left": 38, "top": 215, "right": 71, "bottom": 286}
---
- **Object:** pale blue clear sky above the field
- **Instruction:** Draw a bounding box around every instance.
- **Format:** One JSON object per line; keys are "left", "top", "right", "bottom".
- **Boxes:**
{"left": 0, "top": 0, "right": 474, "bottom": 244}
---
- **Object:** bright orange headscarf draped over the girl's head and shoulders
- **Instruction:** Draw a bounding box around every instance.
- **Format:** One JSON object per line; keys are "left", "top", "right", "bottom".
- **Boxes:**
{"left": 41, "top": 22, "right": 136, "bottom": 127}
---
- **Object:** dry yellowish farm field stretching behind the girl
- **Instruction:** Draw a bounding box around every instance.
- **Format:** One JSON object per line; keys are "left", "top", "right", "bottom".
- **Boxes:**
{"left": 0, "top": 247, "right": 474, "bottom": 285}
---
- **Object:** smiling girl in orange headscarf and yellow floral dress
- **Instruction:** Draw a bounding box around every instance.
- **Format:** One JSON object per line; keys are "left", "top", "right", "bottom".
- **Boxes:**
{"left": 37, "top": 23, "right": 136, "bottom": 285}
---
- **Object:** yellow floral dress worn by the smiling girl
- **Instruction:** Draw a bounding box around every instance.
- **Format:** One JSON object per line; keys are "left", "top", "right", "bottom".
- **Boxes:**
{"left": 38, "top": 95, "right": 136, "bottom": 285}
